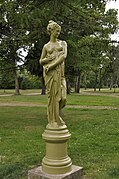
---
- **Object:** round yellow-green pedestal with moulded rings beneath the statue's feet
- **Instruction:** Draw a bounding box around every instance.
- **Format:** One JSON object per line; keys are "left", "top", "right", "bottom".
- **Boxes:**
{"left": 42, "top": 125, "right": 72, "bottom": 174}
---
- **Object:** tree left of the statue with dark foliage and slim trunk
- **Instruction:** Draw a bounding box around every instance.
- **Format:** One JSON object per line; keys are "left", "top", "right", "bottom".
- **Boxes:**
{"left": 0, "top": 0, "right": 54, "bottom": 94}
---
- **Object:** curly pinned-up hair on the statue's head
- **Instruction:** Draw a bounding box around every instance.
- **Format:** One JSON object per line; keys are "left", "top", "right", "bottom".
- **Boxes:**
{"left": 47, "top": 20, "right": 61, "bottom": 35}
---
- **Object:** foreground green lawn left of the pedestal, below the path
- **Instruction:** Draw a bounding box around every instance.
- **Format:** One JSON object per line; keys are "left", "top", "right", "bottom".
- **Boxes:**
{"left": 0, "top": 107, "right": 46, "bottom": 179}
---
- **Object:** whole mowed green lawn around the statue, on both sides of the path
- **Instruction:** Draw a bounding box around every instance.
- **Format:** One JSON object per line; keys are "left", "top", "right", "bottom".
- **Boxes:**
{"left": 0, "top": 91, "right": 119, "bottom": 179}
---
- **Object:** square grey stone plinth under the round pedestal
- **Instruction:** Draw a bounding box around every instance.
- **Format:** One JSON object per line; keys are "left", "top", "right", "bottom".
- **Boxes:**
{"left": 28, "top": 165, "right": 83, "bottom": 179}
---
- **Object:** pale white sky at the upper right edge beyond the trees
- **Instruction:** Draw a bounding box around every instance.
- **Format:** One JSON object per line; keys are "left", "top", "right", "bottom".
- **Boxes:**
{"left": 106, "top": 0, "right": 119, "bottom": 42}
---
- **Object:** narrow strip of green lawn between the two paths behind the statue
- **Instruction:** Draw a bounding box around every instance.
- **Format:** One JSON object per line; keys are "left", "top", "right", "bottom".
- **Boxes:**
{"left": 0, "top": 93, "right": 119, "bottom": 107}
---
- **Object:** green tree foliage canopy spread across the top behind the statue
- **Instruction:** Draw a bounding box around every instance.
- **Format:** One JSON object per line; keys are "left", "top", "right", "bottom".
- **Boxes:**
{"left": 0, "top": 0, "right": 118, "bottom": 91}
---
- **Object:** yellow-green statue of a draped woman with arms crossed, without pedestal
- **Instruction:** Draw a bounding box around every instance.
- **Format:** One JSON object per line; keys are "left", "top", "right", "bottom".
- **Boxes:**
{"left": 40, "top": 20, "right": 67, "bottom": 126}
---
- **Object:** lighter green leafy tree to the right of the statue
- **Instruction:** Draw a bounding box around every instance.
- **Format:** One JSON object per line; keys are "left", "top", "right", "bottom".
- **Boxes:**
{"left": 65, "top": 1, "right": 117, "bottom": 92}
